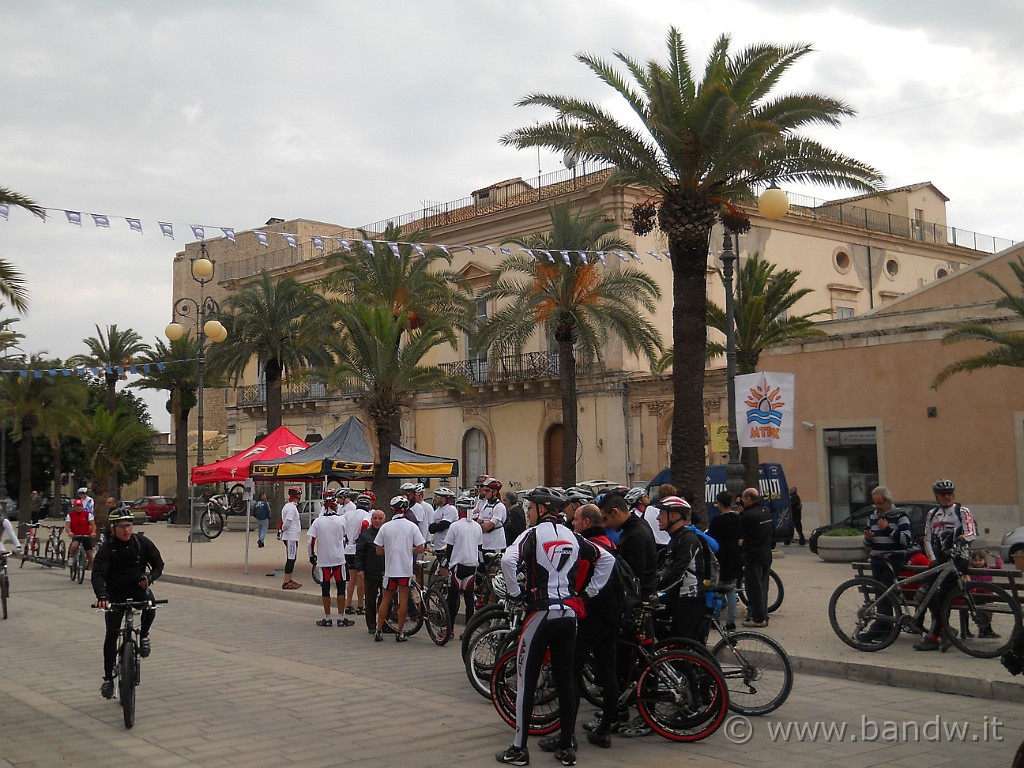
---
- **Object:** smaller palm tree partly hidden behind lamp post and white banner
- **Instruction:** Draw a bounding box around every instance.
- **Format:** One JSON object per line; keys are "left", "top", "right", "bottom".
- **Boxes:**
{"left": 708, "top": 254, "right": 828, "bottom": 487}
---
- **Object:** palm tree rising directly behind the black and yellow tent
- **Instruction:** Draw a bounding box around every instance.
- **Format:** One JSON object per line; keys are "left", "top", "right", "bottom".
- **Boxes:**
{"left": 322, "top": 301, "right": 464, "bottom": 505}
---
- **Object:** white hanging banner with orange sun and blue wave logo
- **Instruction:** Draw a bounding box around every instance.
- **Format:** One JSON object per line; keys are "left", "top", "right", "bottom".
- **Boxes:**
{"left": 736, "top": 372, "right": 796, "bottom": 449}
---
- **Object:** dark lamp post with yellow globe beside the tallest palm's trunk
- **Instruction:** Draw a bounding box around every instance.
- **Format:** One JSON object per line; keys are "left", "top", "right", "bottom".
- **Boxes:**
{"left": 719, "top": 181, "right": 790, "bottom": 499}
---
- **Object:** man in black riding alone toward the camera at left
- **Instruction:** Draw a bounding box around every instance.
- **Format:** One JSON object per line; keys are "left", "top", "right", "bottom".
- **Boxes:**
{"left": 92, "top": 510, "right": 164, "bottom": 698}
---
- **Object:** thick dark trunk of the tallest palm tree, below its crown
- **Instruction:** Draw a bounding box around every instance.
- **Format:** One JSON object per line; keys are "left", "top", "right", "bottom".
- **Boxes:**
{"left": 669, "top": 237, "right": 710, "bottom": 504}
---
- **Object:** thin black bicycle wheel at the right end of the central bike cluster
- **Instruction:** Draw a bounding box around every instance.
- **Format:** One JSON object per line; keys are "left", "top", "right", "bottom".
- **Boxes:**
{"left": 712, "top": 632, "right": 793, "bottom": 715}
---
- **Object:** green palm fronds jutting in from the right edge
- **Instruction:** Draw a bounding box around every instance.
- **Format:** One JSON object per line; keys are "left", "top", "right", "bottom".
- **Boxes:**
{"left": 932, "top": 256, "right": 1024, "bottom": 388}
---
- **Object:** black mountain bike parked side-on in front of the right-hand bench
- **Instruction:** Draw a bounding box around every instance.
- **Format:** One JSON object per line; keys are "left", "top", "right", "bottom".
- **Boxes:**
{"left": 828, "top": 540, "right": 1022, "bottom": 658}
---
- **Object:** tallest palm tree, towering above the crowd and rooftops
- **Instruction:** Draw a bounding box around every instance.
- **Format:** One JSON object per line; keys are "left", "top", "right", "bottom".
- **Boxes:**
{"left": 502, "top": 28, "right": 882, "bottom": 499}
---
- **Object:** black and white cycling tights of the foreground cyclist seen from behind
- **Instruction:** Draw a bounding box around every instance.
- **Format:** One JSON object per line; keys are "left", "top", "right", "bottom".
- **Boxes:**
{"left": 512, "top": 608, "right": 575, "bottom": 746}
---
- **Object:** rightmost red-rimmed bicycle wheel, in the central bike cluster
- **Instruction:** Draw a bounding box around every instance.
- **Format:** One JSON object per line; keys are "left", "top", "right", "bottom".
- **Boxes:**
{"left": 637, "top": 651, "right": 729, "bottom": 741}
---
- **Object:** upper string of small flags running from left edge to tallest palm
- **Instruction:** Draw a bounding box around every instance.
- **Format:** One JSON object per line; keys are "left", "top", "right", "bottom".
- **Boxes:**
{"left": 0, "top": 203, "right": 672, "bottom": 267}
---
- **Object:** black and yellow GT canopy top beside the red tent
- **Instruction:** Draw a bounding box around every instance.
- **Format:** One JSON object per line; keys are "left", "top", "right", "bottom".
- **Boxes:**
{"left": 249, "top": 416, "right": 459, "bottom": 480}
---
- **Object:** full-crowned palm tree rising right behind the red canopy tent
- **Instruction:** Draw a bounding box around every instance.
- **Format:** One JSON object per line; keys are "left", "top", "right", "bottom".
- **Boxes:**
{"left": 209, "top": 270, "right": 331, "bottom": 434}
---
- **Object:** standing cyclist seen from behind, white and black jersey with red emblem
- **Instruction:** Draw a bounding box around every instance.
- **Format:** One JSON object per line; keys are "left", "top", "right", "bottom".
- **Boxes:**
{"left": 495, "top": 485, "right": 614, "bottom": 765}
